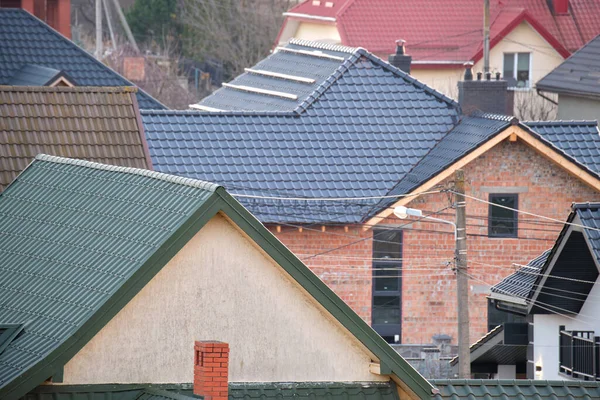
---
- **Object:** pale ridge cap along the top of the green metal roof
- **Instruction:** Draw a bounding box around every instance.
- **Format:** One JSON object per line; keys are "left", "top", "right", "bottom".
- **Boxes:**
{"left": 35, "top": 154, "right": 220, "bottom": 192}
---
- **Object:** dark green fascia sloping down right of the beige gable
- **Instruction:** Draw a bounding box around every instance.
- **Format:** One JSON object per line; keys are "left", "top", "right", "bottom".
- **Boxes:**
{"left": 216, "top": 188, "right": 433, "bottom": 398}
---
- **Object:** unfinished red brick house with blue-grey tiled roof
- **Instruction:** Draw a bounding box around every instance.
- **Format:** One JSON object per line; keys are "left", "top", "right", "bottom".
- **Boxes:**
{"left": 142, "top": 41, "right": 600, "bottom": 343}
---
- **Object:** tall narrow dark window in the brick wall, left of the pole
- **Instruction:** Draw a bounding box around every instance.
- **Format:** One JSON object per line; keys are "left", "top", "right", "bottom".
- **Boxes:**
{"left": 371, "top": 229, "right": 402, "bottom": 343}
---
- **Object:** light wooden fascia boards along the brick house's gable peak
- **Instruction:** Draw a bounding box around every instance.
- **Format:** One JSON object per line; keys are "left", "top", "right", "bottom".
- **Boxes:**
{"left": 363, "top": 125, "right": 600, "bottom": 230}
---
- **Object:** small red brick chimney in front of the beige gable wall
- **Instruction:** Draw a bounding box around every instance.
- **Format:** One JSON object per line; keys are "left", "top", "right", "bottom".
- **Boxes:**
{"left": 194, "top": 341, "right": 229, "bottom": 400}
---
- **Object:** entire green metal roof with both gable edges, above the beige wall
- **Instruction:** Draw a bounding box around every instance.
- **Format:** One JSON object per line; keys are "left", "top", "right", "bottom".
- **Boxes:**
{"left": 0, "top": 155, "right": 432, "bottom": 400}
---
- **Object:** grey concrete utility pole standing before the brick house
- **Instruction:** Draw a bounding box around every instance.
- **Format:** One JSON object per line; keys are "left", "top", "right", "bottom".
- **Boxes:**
{"left": 454, "top": 169, "right": 471, "bottom": 379}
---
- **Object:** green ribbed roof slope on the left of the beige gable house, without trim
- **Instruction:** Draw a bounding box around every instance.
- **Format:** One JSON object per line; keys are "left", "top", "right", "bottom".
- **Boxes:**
{"left": 0, "top": 155, "right": 216, "bottom": 389}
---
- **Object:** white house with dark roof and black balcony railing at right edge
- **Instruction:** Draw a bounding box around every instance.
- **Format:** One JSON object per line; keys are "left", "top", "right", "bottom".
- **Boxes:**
{"left": 460, "top": 202, "right": 600, "bottom": 381}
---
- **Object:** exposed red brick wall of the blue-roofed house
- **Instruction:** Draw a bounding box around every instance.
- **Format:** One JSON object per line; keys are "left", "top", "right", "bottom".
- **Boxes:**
{"left": 272, "top": 141, "right": 600, "bottom": 343}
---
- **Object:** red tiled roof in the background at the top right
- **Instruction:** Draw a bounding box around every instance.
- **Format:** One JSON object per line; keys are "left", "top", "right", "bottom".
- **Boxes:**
{"left": 290, "top": 0, "right": 600, "bottom": 61}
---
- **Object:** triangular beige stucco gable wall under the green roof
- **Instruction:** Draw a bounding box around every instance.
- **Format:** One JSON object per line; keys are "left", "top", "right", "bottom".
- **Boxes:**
{"left": 64, "top": 215, "right": 385, "bottom": 384}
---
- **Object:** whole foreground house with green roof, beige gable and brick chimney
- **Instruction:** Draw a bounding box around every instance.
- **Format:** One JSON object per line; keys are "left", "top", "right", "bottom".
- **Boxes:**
{"left": 0, "top": 155, "right": 433, "bottom": 400}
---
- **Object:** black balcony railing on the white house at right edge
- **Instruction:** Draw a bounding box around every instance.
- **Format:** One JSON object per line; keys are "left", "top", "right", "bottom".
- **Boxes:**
{"left": 559, "top": 328, "right": 600, "bottom": 380}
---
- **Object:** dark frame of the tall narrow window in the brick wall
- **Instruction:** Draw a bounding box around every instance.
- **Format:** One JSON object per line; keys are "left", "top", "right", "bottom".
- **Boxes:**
{"left": 371, "top": 229, "right": 404, "bottom": 343}
